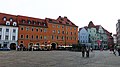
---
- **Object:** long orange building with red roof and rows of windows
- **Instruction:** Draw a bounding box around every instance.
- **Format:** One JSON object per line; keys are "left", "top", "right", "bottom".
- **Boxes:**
{"left": 0, "top": 12, "right": 78, "bottom": 49}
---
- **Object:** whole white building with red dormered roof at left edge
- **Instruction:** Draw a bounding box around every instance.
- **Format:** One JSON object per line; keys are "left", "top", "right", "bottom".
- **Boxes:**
{"left": 0, "top": 14, "right": 18, "bottom": 50}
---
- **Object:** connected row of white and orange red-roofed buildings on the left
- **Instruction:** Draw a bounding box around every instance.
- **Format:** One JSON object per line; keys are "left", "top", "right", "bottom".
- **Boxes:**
{"left": 0, "top": 13, "right": 78, "bottom": 50}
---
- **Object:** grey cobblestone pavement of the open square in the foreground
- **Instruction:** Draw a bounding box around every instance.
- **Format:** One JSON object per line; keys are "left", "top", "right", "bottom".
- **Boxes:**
{"left": 0, "top": 51, "right": 120, "bottom": 67}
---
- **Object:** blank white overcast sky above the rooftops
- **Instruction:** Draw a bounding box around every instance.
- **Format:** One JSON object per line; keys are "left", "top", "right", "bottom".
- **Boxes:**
{"left": 0, "top": 0, "right": 120, "bottom": 34}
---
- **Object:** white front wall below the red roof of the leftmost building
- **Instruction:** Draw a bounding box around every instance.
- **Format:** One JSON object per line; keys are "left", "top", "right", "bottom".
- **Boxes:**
{"left": 0, "top": 26, "right": 18, "bottom": 49}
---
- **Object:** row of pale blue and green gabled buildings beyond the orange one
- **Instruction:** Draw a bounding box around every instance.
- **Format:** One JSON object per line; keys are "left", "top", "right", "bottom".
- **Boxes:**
{"left": 78, "top": 21, "right": 114, "bottom": 49}
